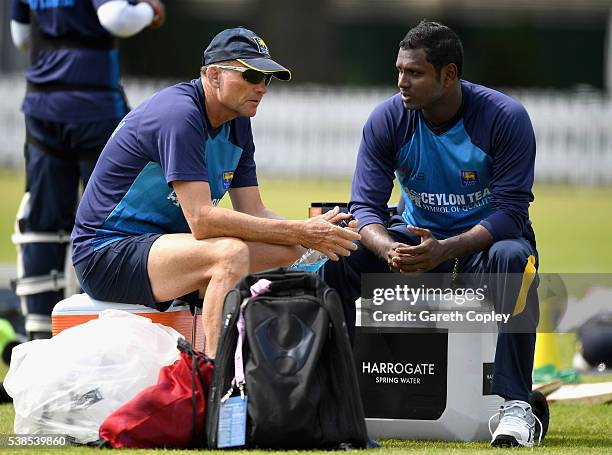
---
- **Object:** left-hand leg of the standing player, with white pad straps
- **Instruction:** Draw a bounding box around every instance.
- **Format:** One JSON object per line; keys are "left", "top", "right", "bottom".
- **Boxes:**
{"left": 18, "top": 117, "right": 78, "bottom": 339}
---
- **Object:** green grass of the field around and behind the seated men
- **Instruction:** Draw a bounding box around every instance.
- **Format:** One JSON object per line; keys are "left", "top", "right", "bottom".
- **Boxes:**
{"left": 0, "top": 175, "right": 612, "bottom": 455}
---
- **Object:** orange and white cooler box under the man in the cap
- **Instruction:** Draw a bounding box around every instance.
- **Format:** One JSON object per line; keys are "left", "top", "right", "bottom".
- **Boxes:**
{"left": 51, "top": 294, "right": 204, "bottom": 351}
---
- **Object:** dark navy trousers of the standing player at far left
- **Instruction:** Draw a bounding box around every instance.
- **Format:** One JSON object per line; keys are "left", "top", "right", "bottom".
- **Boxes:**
{"left": 20, "top": 116, "right": 120, "bottom": 334}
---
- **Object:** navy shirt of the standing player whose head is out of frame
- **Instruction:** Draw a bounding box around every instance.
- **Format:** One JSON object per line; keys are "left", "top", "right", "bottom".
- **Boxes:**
{"left": 12, "top": 0, "right": 127, "bottom": 123}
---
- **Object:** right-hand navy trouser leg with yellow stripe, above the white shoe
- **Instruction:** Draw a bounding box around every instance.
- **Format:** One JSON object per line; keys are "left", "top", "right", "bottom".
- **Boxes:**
{"left": 461, "top": 239, "right": 539, "bottom": 402}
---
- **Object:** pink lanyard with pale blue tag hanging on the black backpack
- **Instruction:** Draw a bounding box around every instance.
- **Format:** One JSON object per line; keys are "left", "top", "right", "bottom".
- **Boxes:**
{"left": 217, "top": 279, "right": 271, "bottom": 449}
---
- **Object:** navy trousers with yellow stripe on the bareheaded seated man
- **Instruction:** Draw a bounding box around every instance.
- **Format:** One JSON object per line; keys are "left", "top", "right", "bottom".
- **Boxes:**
{"left": 321, "top": 217, "right": 539, "bottom": 401}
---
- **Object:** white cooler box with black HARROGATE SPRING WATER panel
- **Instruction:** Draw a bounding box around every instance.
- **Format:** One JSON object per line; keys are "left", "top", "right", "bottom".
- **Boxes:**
{"left": 354, "top": 298, "right": 503, "bottom": 441}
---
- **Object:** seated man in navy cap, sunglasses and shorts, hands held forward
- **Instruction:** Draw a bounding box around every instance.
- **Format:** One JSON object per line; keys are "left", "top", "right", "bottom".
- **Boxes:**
{"left": 72, "top": 28, "right": 360, "bottom": 356}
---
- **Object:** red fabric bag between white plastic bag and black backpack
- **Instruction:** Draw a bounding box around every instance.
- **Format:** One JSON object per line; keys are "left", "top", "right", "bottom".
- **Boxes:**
{"left": 100, "top": 338, "right": 213, "bottom": 449}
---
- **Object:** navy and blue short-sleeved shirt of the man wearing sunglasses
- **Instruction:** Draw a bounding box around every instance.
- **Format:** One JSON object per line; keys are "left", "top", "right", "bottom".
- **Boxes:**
{"left": 72, "top": 79, "right": 257, "bottom": 264}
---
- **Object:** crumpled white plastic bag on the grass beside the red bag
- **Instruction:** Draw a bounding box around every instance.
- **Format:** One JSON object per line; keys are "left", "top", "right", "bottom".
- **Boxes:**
{"left": 4, "top": 310, "right": 181, "bottom": 443}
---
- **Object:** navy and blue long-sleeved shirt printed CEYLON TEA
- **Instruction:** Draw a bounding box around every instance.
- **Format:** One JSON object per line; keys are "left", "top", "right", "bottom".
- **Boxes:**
{"left": 349, "top": 81, "right": 536, "bottom": 241}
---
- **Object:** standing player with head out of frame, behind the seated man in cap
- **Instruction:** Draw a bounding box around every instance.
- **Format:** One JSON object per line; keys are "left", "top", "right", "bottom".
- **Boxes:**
{"left": 11, "top": 0, "right": 165, "bottom": 339}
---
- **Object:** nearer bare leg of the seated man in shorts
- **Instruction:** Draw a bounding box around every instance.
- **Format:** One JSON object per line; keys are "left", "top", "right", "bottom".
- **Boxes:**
{"left": 147, "top": 234, "right": 250, "bottom": 357}
